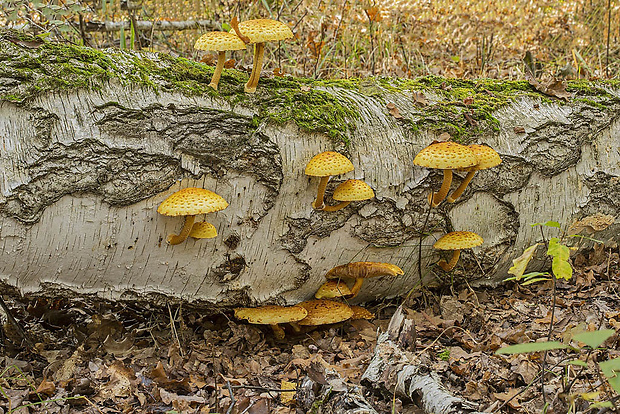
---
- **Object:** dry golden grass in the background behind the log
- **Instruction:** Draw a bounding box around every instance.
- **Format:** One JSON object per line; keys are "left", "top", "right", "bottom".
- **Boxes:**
{"left": 1, "top": 0, "right": 620, "bottom": 79}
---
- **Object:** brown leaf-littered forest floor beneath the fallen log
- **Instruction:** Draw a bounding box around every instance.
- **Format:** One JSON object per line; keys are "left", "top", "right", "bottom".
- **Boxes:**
{"left": 0, "top": 243, "right": 620, "bottom": 414}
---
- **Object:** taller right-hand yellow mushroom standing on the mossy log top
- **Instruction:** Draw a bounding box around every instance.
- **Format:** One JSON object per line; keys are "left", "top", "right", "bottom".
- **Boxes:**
{"left": 230, "top": 17, "right": 293, "bottom": 93}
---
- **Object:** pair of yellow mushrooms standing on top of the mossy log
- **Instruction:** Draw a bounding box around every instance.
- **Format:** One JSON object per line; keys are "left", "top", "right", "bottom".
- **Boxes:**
{"left": 194, "top": 17, "right": 293, "bottom": 93}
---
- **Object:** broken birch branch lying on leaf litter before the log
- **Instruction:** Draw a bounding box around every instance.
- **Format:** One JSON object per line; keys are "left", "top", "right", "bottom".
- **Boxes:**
{"left": 362, "top": 306, "right": 481, "bottom": 414}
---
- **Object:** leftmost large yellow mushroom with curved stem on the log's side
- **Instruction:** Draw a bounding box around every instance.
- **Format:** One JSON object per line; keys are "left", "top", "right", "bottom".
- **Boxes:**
{"left": 157, "top": 187, "right": 228, "bottom": 245}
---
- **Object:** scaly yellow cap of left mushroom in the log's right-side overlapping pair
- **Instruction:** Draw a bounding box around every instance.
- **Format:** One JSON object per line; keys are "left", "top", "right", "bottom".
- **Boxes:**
{"left": 413, "top": 141, "right": 478, "bottom": 170}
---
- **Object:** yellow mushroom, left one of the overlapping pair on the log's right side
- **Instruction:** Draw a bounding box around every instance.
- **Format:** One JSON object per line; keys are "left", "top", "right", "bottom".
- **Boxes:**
{"left": 413, "top": 141, "right": 478, "bottom": 207}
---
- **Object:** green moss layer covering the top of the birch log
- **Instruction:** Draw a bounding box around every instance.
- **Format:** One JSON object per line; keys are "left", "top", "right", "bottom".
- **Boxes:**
{"left": 0, "top": 31, "right": 620, "bottom": 143}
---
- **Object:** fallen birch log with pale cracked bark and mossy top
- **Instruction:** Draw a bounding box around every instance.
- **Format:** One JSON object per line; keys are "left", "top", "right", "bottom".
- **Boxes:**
{"left": 0, "top": 32, "right": 620, "bottom": 306}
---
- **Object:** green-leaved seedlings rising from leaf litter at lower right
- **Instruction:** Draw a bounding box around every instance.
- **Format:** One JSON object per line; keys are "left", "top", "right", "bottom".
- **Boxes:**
{"left": 496, "top": 221, "right": 620, "bottom": 413}
